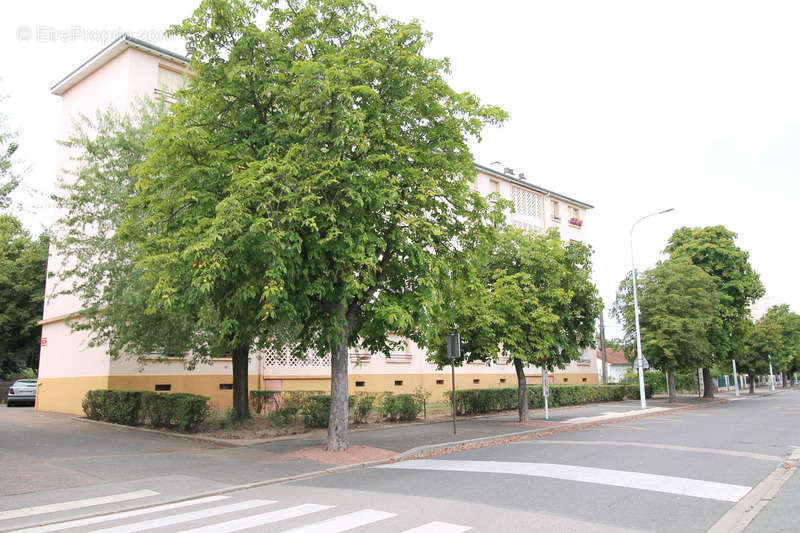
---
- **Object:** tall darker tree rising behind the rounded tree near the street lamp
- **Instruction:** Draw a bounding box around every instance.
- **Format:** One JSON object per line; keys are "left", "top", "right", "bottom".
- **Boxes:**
{"left": 665, "top": 226, "right": 764, "bottom": 398}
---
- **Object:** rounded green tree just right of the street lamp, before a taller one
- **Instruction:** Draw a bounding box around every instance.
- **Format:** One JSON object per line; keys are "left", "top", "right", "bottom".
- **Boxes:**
{"left": 621, "top": 258, "right": 717, "bottom": 402}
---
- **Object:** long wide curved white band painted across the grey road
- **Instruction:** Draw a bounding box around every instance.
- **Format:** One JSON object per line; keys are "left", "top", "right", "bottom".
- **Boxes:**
{"left": 375, "top": 459, "right": 750, "bottom": 502}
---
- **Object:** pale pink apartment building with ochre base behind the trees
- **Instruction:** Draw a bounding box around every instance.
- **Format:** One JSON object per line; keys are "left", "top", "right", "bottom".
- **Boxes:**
{"left": 37, "top": 36, "right": 598, "bottom": 413}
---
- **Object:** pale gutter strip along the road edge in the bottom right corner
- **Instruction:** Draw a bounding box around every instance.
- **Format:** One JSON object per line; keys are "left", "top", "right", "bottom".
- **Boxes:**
{"left": 707, "top": 448, "right": 800, "bottom": 533}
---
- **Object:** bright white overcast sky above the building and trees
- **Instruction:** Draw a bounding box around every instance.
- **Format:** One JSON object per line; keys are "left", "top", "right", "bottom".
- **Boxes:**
{"left": 0, "top": 0, "right": 800, "bottom": 337}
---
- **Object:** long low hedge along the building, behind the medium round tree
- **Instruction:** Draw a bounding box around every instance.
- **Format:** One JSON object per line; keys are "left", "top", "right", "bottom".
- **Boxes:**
{"left": 448, "top": 385, "right": 652, "bottom": 415}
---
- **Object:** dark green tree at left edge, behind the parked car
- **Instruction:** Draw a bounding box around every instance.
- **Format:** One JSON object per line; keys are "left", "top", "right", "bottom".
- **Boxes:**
{"left": 0, "top": 215, "right": 49, "bottom": 377}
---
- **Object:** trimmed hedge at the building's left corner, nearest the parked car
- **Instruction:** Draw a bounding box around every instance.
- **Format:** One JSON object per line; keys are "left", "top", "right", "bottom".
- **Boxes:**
{"left": 83, "top": 389, "right": 211, "bottom": 431}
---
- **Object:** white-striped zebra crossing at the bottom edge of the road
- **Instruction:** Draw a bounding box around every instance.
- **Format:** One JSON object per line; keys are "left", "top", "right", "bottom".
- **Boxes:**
{"left": 6, "top": 495, "right": 472, "bottom": 533}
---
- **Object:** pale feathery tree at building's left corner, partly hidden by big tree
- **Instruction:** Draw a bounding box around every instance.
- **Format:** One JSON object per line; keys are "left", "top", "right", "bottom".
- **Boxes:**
{"left": 50, "top": 101, "right": 223, "bottom": 382}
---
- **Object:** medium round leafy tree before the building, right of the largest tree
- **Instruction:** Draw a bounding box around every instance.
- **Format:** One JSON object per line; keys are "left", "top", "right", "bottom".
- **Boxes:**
{"left": 423, "top": 227, "right": 601, "bottom": 422}
